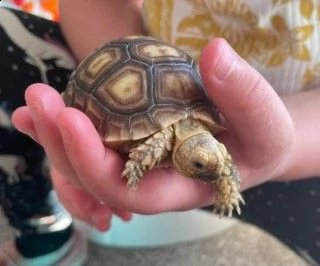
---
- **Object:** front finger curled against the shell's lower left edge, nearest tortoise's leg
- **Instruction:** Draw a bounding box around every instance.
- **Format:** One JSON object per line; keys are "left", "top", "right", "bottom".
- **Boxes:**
{"left": 57, "top": 108, "right": 126, "bottom": 204}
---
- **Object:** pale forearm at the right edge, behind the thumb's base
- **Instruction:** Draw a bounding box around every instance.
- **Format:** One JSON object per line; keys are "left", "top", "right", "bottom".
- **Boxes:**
{"left": 275, "top": 89, "right": 320, "bottom": 180}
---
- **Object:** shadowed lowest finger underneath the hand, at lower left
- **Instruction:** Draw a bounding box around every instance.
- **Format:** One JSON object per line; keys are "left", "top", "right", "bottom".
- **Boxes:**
{"left": 51, "top": 168, "right": 112, "bottom": 231}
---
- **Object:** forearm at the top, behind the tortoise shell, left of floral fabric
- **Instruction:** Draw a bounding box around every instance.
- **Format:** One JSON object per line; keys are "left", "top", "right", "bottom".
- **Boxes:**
{"left": 60, "top": 0, "right": 143, "bottom": 60}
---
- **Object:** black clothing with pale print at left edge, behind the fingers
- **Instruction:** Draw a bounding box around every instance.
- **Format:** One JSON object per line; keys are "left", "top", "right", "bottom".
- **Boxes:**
{"left": 0, "top": 7, "right": 75, "bottom": 257}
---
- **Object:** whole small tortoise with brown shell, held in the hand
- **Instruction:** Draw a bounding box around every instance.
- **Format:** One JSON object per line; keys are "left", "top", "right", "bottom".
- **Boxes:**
{"left": 63, "top": 36, "right": 244, "bottom": 217}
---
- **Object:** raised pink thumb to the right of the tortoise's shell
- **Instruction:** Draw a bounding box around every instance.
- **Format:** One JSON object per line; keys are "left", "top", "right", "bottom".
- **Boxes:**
{"left": 200, "top": 38, "right": 293, "bottom": 174}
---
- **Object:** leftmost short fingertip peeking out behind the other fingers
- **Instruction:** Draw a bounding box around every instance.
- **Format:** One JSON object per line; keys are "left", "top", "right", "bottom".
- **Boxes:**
{"left": 11, "top": 106, "right": 39, "bottom": 143}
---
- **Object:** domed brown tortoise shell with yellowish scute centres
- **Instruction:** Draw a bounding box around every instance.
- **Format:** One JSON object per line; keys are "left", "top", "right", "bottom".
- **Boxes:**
{"left": 63, "top": 36, "right": 222, "bottom": 148}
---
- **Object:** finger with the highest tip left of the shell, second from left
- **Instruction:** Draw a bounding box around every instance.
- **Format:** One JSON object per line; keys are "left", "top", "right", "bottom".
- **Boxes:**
{"left": 25, "top": 84, "right": 82, "bottom": 187}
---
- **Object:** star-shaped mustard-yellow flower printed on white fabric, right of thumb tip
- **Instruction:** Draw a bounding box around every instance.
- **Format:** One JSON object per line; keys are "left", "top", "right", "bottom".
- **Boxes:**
{"left": 266, "top": 15, "right": 314, "bottom": 67}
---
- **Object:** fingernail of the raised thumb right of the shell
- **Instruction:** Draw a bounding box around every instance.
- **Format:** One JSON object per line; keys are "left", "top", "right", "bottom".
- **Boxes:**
{"left": 214, "top": 42, "right": 237, "bottom": 81}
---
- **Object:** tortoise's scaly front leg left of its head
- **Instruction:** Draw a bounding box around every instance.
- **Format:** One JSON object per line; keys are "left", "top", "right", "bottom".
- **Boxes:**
{"left": 122, "top": 127, "right": 174, "bottom": 189}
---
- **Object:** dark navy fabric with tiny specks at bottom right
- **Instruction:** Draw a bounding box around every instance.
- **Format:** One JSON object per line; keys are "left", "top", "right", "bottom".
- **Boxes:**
{"left": 241, "top": 180, "right": 320, "bottom": 265}
